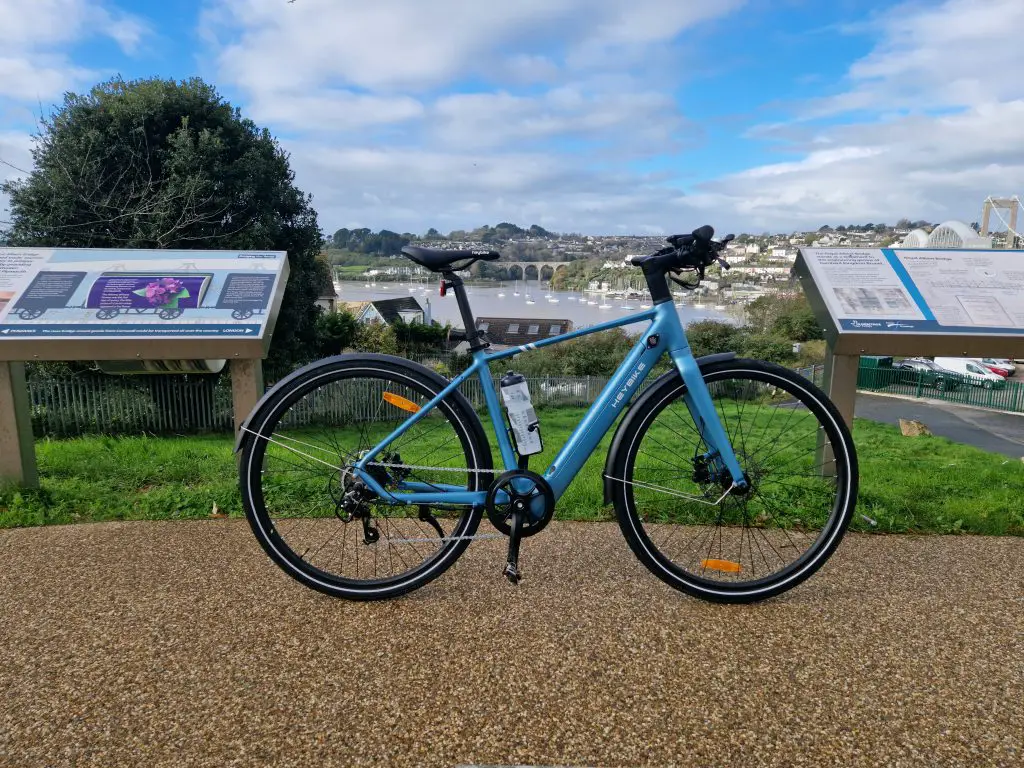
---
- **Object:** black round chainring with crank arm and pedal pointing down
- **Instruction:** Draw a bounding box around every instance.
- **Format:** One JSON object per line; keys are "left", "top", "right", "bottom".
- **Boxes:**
{"left": 484, "top": 469, "right": 555, "bottom": 584}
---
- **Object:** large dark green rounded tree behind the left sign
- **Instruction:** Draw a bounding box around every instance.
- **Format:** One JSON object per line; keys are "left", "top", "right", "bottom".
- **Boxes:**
{"left": 3, "top": 78, "right": 324, "bottom": 376}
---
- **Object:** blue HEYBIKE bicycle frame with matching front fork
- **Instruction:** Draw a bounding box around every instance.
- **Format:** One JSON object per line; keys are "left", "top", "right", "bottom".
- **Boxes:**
{"left": 354, "top": 302, "right": 743, "bottom": 506}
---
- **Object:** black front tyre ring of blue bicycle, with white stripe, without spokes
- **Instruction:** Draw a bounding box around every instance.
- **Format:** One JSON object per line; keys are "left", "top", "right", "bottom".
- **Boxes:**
{"left": 608, "top": 358, "right": 858, "bottom": 603}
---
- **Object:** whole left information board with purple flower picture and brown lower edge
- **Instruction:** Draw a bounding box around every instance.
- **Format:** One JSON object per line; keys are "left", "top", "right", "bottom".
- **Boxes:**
{"left": 0, "top": 248, "right": 288, "bottom": 360}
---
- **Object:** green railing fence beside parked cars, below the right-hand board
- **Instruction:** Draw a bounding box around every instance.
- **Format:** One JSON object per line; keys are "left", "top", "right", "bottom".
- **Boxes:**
{"left": 857, "top": 362, "right": 1024, "bottom": 413}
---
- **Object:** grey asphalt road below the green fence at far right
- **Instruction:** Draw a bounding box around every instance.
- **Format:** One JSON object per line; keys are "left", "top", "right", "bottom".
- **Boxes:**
{"left": 854, "top": 393, "right": 1024, "bottom": 459}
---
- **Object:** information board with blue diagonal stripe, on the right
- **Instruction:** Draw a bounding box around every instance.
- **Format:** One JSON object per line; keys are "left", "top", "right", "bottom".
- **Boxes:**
{"left": 796, "top": 248, "right": 1024, "bottom": 357}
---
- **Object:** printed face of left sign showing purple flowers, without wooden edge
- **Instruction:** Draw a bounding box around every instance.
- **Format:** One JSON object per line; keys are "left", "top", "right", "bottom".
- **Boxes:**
{"left": 0, "top": 248, "right": 288, "bottom": 340}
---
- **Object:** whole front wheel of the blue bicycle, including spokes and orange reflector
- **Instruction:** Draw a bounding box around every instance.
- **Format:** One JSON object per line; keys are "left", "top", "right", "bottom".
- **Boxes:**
{"left": 609, "top": 359, "right": 857, "bottom": 602}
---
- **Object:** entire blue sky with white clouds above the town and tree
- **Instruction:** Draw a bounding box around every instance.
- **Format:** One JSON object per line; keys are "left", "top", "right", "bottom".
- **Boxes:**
{"left": 0, "top": 0, "right": 1024, "bottom": 233}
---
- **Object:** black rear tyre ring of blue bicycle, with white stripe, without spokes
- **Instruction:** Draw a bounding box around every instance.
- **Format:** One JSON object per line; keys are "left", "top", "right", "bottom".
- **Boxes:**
{"left": 239, "top": 354, "right": 493, "bottom": 600}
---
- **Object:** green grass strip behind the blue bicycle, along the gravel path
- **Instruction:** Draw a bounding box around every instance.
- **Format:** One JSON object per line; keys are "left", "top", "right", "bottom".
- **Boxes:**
{"left": 0, "top": 409, "right": 1024, "bottom": 536}
